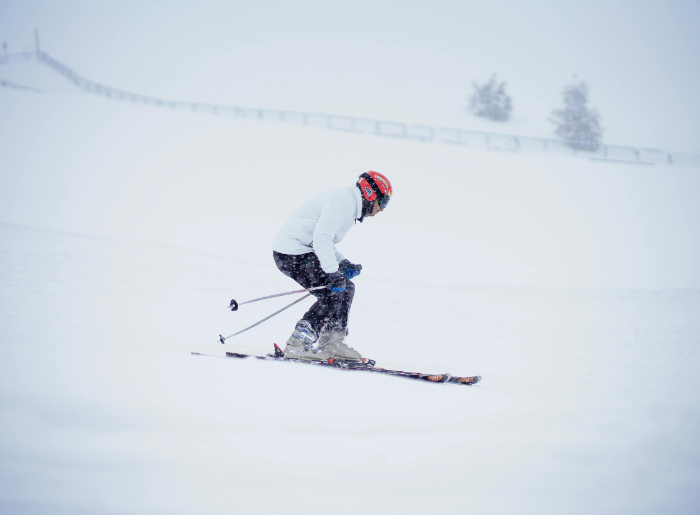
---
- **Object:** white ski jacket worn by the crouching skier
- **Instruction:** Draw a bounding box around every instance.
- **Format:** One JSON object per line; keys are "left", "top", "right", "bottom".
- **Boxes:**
{"left": 272, "top": 186, "right": 362, "bottom": 274}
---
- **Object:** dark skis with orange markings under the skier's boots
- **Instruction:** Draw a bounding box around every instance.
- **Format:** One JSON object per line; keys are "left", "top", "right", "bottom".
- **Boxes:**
{"left": 192, "top": 344, "right": 481, "bottom": 386}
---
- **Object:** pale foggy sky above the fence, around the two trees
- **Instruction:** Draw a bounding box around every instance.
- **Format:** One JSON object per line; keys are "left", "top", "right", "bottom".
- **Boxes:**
{"left": 0, "top": 1, "right": 700, "bottom": 152}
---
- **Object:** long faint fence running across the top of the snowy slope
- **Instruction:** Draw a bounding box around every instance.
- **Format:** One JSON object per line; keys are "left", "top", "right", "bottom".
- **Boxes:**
{"left": 0, "top": 49, "right": 700, "bottom": 166}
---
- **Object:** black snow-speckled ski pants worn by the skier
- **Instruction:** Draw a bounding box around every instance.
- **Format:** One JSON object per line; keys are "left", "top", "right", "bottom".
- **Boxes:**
{"left": 272, "top": 251, "right": 355, "bottom": 335}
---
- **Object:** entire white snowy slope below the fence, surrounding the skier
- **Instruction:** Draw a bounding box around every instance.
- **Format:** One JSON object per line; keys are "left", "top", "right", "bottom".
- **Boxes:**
{"left": 0, "top": 4, "right": 700, "bottom": 515}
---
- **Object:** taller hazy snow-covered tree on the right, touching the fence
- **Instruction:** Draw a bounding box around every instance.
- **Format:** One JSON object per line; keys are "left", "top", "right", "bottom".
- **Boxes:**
{"left": 550, "top": 81, "right": 602, "bottom": 152}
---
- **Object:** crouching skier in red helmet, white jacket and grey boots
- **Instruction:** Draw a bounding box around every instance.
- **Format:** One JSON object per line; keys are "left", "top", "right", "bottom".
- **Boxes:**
{"left": 272, "top": 171, "right": 392, "bottom": 361}
